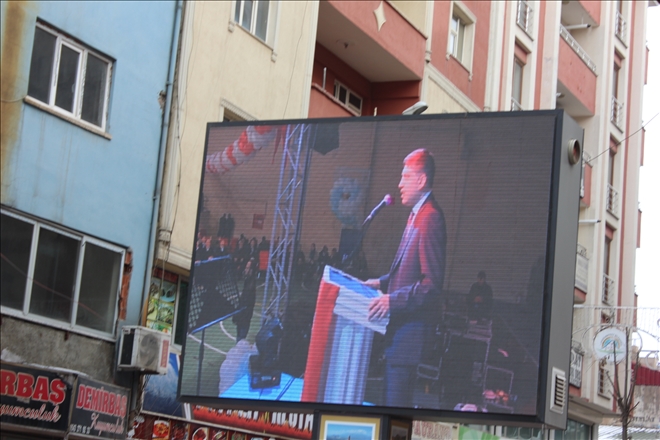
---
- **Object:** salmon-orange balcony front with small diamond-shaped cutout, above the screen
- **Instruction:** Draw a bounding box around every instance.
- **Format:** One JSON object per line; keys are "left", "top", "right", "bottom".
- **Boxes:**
{"left": 328, "top": 0, "right": 426, "bottom": 78}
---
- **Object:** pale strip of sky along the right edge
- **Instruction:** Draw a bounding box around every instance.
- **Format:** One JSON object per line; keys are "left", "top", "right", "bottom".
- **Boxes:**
{"left": 635, "top": 6, "right": 660, "bottom": 312}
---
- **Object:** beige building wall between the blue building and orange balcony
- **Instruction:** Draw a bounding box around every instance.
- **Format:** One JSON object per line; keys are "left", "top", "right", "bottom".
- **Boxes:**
{"left": 157, "top": 1, "right": 318, "bottom": 274}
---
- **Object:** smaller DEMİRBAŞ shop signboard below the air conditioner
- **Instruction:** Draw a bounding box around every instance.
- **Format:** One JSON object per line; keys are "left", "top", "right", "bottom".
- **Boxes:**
{"left": 69, "top": 377, "right": 129, "bottom": 439}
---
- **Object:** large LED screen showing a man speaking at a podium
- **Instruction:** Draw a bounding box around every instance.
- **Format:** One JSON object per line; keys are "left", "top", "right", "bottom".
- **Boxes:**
{"left": 179, "top": 112, "right": 570, "bottom": 416}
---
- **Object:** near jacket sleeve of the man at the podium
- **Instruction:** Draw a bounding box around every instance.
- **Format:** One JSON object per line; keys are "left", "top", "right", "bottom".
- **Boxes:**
{"left": 381, "top": 203, "right": 447, "bottom": 317}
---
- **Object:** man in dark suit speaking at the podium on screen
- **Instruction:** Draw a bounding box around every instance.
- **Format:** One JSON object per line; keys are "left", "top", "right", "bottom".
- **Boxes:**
{"left": 366, "top": 149, "right": 447, "bottom": 407}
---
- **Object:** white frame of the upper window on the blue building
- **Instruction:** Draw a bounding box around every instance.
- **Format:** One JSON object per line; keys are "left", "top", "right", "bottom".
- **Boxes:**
{"left": 27, "top": 22, "right": 114, "bottom": 132}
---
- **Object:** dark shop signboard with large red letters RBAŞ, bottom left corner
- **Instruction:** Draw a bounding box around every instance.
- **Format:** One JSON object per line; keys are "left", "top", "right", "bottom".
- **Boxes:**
{"left": 0, "top": 362, "right": 74, "bottom": 432}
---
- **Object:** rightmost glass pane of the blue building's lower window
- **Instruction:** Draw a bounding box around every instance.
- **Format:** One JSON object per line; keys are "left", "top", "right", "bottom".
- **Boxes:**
{"left": 76, "top": 242, "right": 121, "bottom": 333}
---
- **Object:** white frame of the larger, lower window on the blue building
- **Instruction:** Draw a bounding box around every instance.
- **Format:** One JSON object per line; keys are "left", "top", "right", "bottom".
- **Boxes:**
{"left": 0, "top": 209, "right": 126, "bottom": 341}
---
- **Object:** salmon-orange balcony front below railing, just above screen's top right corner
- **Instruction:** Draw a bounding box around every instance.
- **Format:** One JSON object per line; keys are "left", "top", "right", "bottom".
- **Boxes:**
{"left": 557, "top": 38, "right": 596, "bottom": 114}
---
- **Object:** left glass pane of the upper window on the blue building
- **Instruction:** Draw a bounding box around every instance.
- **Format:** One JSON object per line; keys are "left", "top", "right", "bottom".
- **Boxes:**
{"left": 28, "top": 28, "right": 57, "bottom": 103}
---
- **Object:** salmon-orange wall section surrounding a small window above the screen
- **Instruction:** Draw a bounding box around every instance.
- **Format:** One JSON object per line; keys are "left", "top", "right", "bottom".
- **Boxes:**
{"left": 431, "top": 0, "right": 491, "bottom": 108}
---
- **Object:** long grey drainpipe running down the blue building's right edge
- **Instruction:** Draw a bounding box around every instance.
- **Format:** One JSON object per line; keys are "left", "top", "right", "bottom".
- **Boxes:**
{"left": 138, "top": 0, "right": 183, "bottom": 322}
